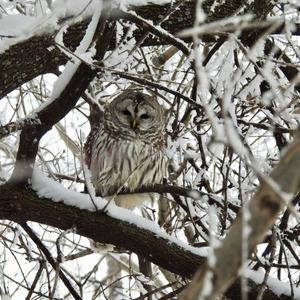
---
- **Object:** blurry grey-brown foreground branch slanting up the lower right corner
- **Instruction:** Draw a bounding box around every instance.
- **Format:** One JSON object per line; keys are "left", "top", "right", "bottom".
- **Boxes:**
{"left": 181, "top": 134, "right": 300, "bottom": 300}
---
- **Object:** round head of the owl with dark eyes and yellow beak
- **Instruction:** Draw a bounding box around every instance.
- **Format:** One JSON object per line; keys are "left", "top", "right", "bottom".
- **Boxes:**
{"left": 105, "top": 89, "right": 165, "bottom": 138}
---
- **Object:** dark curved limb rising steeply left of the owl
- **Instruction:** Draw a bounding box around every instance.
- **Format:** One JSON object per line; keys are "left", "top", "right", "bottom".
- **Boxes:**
{"left": 10, "top": 9, "right": 114, "bottom": 184}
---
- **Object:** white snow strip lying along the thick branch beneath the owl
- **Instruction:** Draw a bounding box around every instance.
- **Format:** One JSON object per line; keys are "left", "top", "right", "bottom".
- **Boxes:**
{"left": 32, "top": 170, "right": 207, "bottom": 256}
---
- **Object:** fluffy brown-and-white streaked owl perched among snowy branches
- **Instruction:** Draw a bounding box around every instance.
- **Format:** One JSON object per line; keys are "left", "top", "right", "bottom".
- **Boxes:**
{"left": 85, "top": 89, "right": 167, "bottom": 208}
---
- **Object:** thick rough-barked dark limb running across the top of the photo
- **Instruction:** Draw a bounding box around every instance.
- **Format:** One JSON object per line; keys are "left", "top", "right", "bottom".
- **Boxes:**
{"left": 0, "top": 0, "right": 274, "bottom": 99}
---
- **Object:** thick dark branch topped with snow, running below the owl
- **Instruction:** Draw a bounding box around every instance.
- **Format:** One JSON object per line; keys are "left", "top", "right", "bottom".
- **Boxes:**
{"left": 0, "top": 178, "right": 206, "bottom": 277}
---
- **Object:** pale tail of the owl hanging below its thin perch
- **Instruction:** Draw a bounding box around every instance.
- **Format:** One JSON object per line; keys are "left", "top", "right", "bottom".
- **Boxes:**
{"left": 106, "top": 193, "right": 153, "bottom": 209}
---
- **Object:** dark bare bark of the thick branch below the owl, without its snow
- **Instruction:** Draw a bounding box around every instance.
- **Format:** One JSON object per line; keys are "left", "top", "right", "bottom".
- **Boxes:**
{"left": 0, "top": 184, "right": 288, "bottom": 300}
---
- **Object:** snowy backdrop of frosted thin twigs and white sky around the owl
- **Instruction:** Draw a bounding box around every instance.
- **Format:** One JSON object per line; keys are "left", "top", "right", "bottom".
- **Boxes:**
{"left": 0, "top": 0, "right": 300, "bottom": 300}
